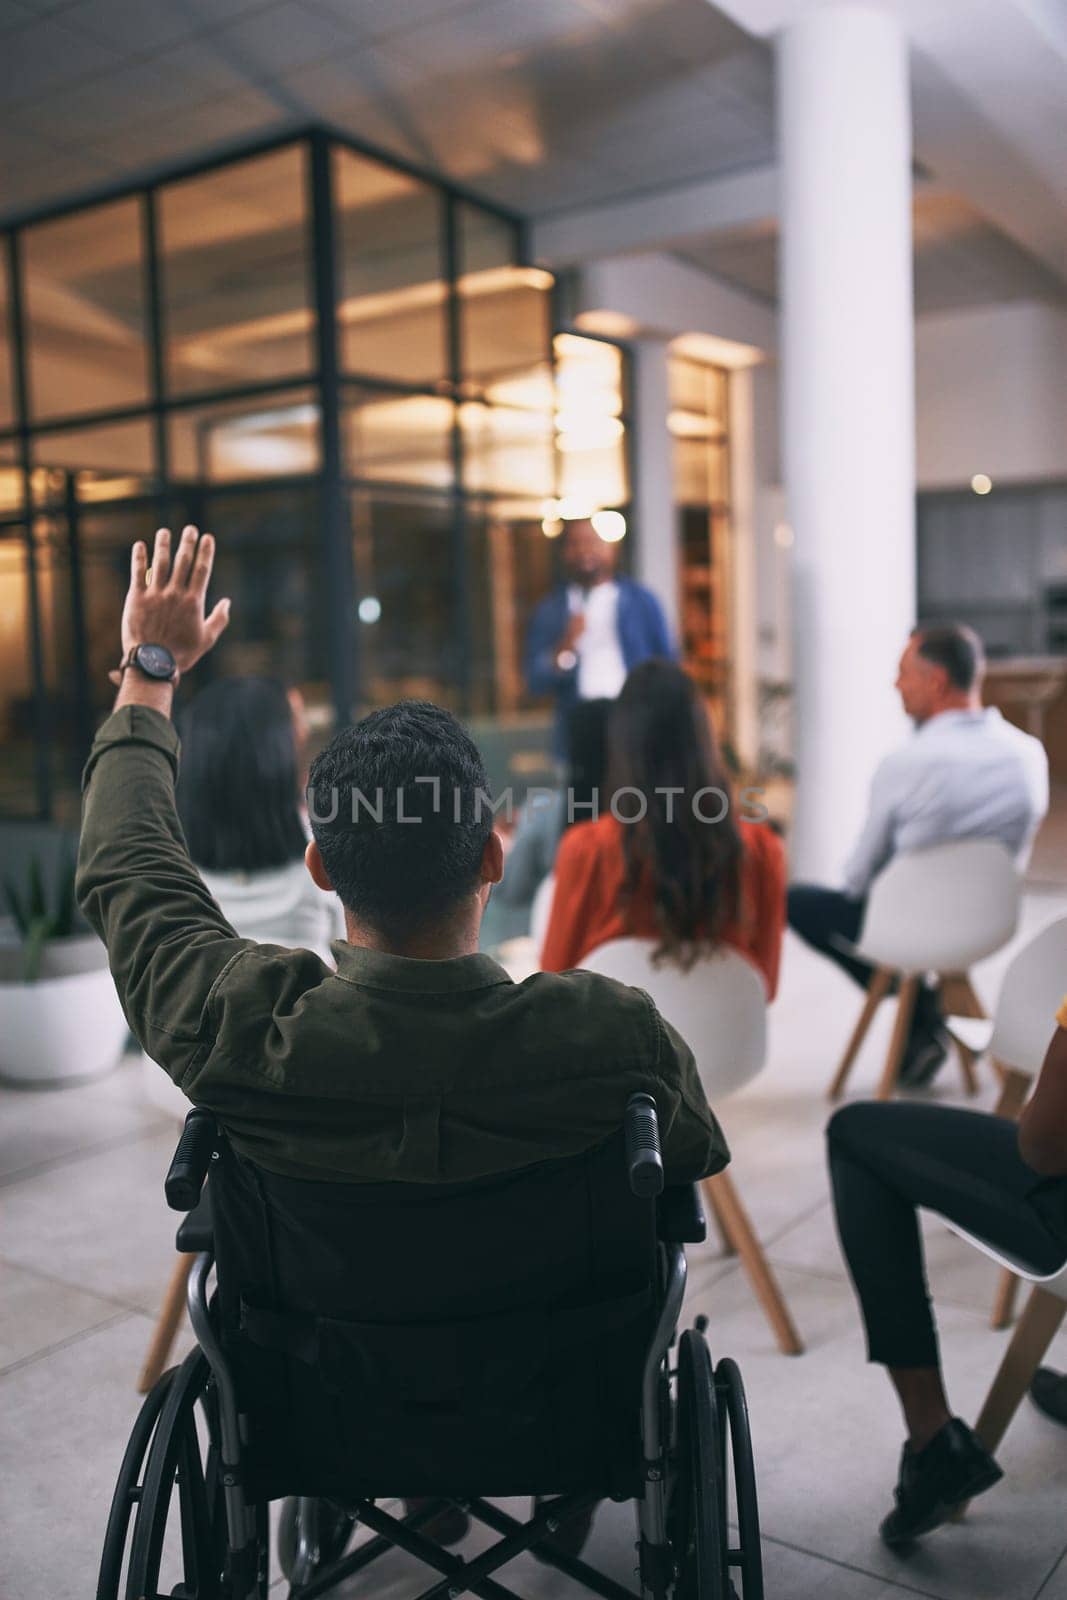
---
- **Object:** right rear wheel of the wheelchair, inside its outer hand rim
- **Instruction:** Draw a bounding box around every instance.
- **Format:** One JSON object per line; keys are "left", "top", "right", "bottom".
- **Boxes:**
{"left": 669, "top": 1328, "right": 731, "bottom": 1600}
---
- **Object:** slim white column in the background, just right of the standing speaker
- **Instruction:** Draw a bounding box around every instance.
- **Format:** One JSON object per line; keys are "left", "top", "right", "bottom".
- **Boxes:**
{"left": 632, "top": 339, "right": 680, "bottom": 638}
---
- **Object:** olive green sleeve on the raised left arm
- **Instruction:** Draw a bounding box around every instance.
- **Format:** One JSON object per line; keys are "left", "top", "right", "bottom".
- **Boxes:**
{"left": 75, "top": 706, "right": 287, "bottom": 1083}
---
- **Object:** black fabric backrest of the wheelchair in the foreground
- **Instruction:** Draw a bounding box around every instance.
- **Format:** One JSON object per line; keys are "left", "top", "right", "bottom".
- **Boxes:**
{"left": 211, "top": 1136, "right": 657, "bottom": 1499}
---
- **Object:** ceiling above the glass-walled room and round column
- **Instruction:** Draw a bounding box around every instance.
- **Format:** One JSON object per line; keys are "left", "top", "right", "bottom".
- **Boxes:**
{"left": 0, "top": 0, "right": 1067, "bottom": 309}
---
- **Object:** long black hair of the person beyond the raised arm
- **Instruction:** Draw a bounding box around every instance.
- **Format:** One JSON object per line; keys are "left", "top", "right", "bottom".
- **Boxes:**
{"left": 178, "top": 677, "right": 307, "bottom": 872}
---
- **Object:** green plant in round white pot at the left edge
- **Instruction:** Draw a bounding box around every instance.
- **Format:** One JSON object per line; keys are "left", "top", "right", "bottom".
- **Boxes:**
{"left": 0, "top": 850, "right": 126, "bottom": 1088}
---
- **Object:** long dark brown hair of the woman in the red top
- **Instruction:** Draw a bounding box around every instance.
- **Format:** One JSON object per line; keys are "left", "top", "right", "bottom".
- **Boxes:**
{"left": 608, "top": 661, "right": 744, "bottom": 970}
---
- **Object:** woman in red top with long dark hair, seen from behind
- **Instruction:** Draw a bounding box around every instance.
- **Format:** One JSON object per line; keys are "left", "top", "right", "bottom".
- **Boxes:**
{"left": 541, "top": 661, "right": 785, "bottom": 1000}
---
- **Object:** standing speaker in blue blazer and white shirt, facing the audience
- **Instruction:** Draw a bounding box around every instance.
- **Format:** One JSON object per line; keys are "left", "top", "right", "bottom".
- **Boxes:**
{"left": 525, "top": 517, "right": 675, "bottom": 757}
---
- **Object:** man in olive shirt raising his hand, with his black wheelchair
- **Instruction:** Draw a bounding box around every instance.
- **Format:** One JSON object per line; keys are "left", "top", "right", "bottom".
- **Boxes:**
{"left": 85, "top": 528, "right": 761, "bottom": 1600}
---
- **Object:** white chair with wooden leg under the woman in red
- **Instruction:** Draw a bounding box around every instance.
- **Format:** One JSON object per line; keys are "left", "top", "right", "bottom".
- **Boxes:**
{"left": 582, "top": 939, "right": 803, "bottom": 1355}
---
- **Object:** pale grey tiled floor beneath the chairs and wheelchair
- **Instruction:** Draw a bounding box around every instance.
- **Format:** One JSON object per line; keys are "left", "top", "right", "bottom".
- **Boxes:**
{"left": 0, "top": 883, "right": 1067, "bottom": 1600}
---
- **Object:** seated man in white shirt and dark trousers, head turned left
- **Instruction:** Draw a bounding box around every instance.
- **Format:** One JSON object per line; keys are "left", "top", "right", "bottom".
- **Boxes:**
{"left": 789, "top": 626, "right": 1048, "bottom": 1085}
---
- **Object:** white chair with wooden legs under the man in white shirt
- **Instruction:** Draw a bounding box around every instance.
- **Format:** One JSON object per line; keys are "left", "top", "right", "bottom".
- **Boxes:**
{"left": 830, "top": 838, "right": 1022, "bottom": 1101}
